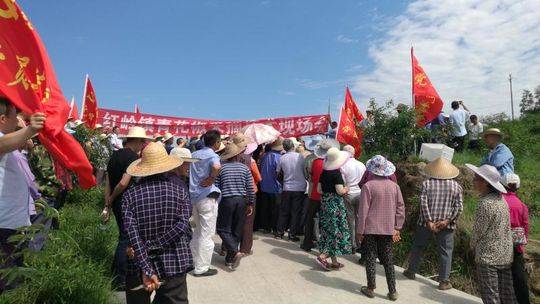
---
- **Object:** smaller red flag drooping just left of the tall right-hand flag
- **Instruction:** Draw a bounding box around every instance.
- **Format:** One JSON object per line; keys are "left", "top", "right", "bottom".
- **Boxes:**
{"left": 336, "top": 88, "right": 364, "bottom": 157}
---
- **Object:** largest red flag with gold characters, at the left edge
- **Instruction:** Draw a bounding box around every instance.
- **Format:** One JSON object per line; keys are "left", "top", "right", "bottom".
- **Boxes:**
{"left": 0, "top": 0, "right": 96, "bottom": 188}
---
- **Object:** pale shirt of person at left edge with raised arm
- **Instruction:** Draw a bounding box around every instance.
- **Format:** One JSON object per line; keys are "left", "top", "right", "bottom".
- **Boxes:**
{"left": 0, "top": 132, "right": 30, "bottom": 229}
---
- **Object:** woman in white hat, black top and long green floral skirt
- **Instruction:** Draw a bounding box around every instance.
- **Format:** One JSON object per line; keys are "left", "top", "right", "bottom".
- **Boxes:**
{"left": 317, "top": 148, "right": 352, "bottom": 271}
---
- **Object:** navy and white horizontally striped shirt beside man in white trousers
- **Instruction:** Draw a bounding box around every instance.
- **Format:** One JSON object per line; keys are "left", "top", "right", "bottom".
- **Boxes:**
{"left": 215, "top": 162, "right": 255, "bottom": 205}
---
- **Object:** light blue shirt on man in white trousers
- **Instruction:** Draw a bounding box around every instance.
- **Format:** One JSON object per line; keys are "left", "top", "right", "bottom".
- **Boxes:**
{"left": 189, "top": 147, "right": 221, "bottom": 205}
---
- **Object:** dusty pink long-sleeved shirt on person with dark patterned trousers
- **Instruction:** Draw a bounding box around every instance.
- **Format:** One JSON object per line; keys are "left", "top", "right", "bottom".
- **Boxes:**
{"left": 356, "top": 176, "right": 405, "bottom": 235}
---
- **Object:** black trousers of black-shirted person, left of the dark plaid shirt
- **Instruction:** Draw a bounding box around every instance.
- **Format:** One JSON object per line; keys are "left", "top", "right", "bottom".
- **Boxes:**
{"left": 112, "top": 201, "right": 129, "bottom": 285}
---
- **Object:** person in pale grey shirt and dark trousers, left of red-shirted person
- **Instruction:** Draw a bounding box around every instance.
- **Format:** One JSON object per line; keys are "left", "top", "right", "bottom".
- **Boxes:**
{"left": 275, "top": 138, "right": 307, "bottom": 242}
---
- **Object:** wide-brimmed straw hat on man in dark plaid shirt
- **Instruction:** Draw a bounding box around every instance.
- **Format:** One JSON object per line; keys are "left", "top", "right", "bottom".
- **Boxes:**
{"left": 126, "top": 142, "right": 183, "bottom": 177}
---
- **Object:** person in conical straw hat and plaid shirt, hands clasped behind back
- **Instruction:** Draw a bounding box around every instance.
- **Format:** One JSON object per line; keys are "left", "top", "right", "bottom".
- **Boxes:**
{"left": 403, "top": 157, "right": 463, "bottom": 290}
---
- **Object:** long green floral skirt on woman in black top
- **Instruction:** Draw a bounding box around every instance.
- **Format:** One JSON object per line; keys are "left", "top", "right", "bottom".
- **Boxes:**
{"left": 319, "top": 193, "right": 352, "bottom": 256}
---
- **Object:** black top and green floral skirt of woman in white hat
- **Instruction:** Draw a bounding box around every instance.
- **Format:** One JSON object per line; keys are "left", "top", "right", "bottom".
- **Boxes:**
{"left": 319, "top": 170, "right": 352, "bottom": 256}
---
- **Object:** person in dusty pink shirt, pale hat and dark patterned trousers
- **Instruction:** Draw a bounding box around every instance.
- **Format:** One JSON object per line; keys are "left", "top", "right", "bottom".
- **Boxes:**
{"left": 356, "top": 155, "right": 405, "bottom": 301}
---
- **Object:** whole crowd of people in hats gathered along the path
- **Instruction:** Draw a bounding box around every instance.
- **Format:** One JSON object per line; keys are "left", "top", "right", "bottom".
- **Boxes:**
{"left": 0, "top": 94, "right": 529, "bottom": 303}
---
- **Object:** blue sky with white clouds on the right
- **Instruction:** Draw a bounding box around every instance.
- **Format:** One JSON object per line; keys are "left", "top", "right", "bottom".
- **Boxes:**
{"left": 18, "top": 0, "right": 540, "bottom": 119}
